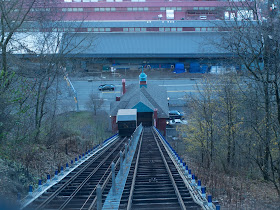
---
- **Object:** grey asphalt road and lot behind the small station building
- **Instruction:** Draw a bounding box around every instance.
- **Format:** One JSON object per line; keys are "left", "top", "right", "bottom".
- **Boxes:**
{"left": 60, "top": 70, "right": 204, "bottom": 137}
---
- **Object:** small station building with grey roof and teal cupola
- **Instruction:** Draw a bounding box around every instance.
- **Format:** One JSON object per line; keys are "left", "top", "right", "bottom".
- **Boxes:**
{"left": 110, "top": 71, "right": 169, "bottom": 135}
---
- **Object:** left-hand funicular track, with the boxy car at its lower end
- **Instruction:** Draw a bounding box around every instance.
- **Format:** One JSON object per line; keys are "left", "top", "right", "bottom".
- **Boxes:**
{"left": 24, "top": 138, "right": 127, "bottom": 209}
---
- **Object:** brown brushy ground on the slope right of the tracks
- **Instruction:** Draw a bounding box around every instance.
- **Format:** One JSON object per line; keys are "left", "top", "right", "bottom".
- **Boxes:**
{"left": 184, "top": 156, "right": 280, "bottom": 210}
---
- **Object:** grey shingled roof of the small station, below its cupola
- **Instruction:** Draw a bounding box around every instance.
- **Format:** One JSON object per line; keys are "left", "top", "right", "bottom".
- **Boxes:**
{"left": 110, "top": 84, "right": 169, "bottom": 118}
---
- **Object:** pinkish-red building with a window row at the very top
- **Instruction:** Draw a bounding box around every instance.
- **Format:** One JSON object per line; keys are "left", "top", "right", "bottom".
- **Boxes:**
{"left": 29, "top": 0, "right": 255, "bottom": 21}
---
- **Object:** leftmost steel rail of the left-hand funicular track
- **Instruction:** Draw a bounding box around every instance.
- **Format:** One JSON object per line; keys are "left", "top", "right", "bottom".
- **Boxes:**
{"left": 31, "top": 137, "right": 125, "bottom": 210}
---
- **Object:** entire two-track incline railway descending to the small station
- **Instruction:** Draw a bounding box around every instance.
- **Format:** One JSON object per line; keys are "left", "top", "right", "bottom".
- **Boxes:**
{"left": 22, "top": 125, "right": 219, "bottom": 210}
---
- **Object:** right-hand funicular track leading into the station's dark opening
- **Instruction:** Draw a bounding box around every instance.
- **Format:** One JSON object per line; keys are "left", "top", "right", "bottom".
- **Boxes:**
{"left": 119, "top": 127, "right": 201, "bottom": 210}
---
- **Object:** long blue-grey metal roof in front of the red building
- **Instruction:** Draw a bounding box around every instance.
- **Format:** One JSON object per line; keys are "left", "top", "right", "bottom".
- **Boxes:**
{"left": 61, "top": 32, "right": 232, "bottom": 58}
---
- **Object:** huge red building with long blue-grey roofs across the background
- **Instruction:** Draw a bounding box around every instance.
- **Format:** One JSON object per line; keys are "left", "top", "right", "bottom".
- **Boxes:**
{"left": 12, "top": 0, "right": 255, "bottom": 71}
